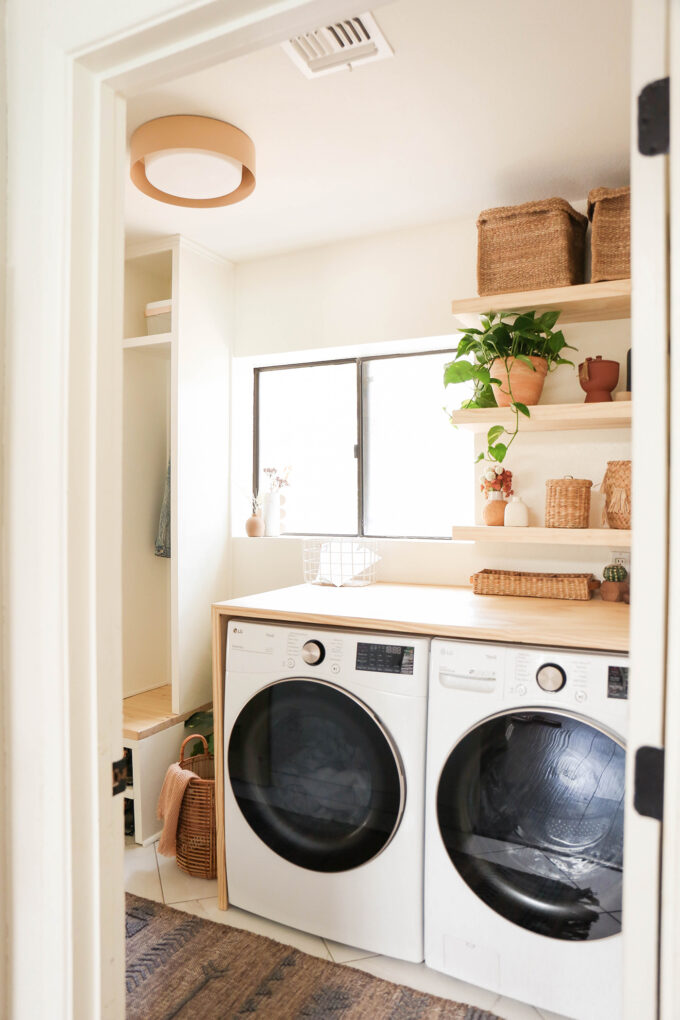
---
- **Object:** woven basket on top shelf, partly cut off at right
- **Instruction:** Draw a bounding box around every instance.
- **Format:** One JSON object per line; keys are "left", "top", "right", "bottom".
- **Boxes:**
{"left": 588, "top": 188, "right": 630, "bottom": 284}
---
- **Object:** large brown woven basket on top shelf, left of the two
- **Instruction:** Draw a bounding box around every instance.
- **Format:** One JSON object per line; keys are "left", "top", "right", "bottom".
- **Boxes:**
{"left": 477, "top": 198, "right": 588, "bottom": 295}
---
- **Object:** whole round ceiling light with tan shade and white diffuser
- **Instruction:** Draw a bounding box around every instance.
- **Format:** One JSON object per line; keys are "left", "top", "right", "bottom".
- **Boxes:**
{"left": 129, "top": 115, "right": 255, "bottom": 209}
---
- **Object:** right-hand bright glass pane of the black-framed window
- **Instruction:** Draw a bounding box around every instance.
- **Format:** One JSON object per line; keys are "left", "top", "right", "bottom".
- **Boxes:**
{"left": 364, "top": 353, "right": 474, "bottom": 539}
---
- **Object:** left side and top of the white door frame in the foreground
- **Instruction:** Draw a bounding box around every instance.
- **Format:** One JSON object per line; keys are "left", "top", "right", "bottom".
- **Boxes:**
{"left": 0, "top": 0, "right": 356, "bottom": 1020}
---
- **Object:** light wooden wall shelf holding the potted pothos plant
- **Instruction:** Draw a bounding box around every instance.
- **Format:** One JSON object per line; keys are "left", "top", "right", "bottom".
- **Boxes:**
{"left": 451, "top": 400, "right": 633, "bottom": 432}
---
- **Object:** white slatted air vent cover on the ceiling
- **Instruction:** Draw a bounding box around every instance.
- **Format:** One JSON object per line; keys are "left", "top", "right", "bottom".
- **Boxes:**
{"left": 281, "top": 13, "right": 394, "bottom": 78}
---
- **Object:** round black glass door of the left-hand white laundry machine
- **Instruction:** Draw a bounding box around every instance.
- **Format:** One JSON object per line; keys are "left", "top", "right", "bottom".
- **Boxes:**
{"left": 227, "top": 679, "right": 405, "bottom": 872}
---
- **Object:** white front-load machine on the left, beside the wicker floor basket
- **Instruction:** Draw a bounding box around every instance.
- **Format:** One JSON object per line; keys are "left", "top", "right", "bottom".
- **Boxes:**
{"left": 224, "top": 620, "right": 429, "bottom": 961}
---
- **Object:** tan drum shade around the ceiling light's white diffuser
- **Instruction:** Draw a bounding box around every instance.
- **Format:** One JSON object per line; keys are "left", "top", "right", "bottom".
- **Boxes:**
{"left": 129, "top": 115, "right": 255, "bottom": 209}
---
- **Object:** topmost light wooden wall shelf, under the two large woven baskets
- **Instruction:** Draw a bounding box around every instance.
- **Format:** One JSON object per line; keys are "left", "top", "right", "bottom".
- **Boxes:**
{"left": 452, "top": 279, "right": 630, "bottom": 325}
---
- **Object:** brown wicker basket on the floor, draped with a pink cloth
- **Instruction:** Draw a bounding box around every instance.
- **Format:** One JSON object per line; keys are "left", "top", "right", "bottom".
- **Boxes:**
{"left": 176, "top": 733, "right": 217, "bottom": 878}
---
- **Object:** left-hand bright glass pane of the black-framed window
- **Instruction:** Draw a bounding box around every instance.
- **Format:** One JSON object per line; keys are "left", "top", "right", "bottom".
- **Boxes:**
{"left": 259, "top": 362, "right": 358, "bottom": 534}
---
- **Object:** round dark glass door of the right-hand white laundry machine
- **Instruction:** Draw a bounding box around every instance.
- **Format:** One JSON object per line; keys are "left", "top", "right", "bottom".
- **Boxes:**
{"left": 437, "top": 711, "right": 626, "bottom": 941}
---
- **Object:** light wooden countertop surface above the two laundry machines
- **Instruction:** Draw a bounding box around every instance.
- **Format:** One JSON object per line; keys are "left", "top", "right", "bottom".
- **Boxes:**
{"left": 214, "top": 583, "right": 629, "bottom": 652}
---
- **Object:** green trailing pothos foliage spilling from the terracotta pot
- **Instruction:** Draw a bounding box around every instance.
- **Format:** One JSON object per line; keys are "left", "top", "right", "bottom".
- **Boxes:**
{"left": 443, "top": 311, "right": 575, "bottom": 464}
